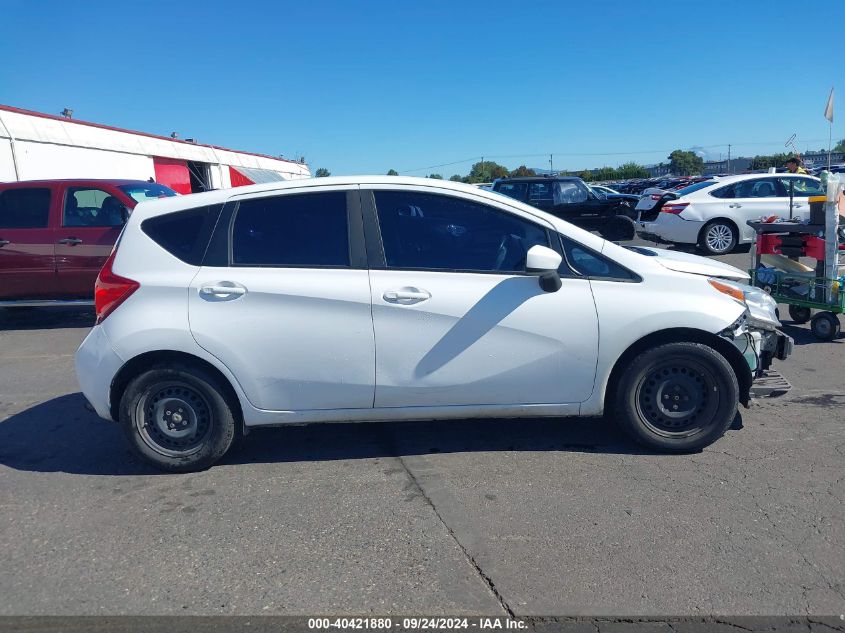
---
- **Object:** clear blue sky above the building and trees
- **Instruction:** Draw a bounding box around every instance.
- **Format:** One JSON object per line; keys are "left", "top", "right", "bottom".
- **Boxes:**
{"left": 0, "top": 0, "right": 845, "bottom": 177}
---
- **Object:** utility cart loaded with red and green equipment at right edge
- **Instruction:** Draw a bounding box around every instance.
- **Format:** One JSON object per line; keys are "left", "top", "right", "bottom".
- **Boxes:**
{"left": 747, "top": 183, "right": 845, "bottom": 341}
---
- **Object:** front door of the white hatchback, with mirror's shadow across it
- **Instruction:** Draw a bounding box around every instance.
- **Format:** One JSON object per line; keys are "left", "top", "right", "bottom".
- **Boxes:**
{"left": 363, "top": 189, "right": 598, "bottom": 407}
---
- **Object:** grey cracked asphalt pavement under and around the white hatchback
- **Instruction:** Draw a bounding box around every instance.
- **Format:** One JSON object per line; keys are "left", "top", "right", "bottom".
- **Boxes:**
{"left": 0, "top": 239, "right": 845, "bottom": 616}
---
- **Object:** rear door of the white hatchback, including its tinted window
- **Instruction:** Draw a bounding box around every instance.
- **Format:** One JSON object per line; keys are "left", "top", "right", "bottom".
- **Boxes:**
{"left": 188, "top": 187, "right": 375, "bottom": 411}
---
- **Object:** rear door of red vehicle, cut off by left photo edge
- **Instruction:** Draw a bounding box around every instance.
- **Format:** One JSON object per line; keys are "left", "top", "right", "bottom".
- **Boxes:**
{"left": 0, "top": 185, "right": 58, "bottom": 299}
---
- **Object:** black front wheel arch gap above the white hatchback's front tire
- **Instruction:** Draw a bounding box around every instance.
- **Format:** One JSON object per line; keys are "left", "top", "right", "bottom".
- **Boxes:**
{"left": 604, "top": 328, "right": 753, "bottom": 411}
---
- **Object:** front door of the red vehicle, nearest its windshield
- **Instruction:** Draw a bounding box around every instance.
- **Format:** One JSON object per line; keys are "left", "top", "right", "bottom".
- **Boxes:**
{"left": 56, "top": 185, "right": 126, "bottom": 297}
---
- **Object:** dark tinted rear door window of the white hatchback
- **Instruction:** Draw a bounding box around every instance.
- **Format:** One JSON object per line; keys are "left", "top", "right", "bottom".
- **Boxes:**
{"left": 232, "top": 191, "right": 350, "bottom": 268}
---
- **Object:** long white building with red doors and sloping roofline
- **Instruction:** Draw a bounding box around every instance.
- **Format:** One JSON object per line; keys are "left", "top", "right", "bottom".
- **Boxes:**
{"left": 0, "top": 105, "right": 311, "bottom": 193}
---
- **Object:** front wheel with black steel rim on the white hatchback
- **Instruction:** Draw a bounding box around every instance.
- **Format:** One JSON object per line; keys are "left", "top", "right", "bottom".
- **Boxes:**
{"left": 615, "top": 343, "right": 739, "bottom": 453}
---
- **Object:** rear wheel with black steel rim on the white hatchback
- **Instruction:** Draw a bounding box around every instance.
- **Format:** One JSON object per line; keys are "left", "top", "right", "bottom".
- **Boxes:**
{"left": 120, "top": 364, "right": 236, "bottom": 473}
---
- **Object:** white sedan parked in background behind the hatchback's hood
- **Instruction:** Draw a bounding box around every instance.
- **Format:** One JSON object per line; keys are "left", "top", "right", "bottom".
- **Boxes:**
{"left": 637, "top": 174, "right": 824, "bottom": 255}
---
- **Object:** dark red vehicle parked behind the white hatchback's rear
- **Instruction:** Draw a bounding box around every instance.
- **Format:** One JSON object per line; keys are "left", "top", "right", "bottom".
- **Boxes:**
{"left": 0, "top": 180, "right": 176, "bottom": 306}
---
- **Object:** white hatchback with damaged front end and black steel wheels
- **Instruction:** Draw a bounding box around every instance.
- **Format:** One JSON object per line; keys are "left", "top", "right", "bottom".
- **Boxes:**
{"left": 76, "top": 177, "right": 792, "bottom": 471}
